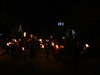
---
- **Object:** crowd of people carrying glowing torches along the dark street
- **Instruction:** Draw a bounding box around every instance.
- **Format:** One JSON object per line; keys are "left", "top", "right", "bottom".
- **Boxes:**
{"left": 3, "top": 34, "right": 89, "bottom": 67}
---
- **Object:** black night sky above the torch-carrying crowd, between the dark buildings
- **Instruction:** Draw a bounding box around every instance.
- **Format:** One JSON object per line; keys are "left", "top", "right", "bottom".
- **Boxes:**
{"left": 9, "top": 0, "right": 65, "bottom": 33}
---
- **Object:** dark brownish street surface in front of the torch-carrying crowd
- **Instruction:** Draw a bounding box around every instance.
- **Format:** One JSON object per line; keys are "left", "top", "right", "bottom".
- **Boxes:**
{"left": 0, "top": 49, "right": 99, "bottom": 75}
